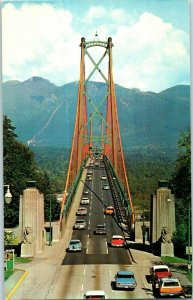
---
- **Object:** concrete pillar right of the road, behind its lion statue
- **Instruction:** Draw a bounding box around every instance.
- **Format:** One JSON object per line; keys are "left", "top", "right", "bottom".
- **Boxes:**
{"left": 151, "top": 180, "right": 176, "bottom": 243}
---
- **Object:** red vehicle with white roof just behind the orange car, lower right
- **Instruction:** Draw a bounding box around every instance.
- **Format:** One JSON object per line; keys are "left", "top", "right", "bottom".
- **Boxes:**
{"left": 149, "top": 265, "right": 172, "bottom": 289}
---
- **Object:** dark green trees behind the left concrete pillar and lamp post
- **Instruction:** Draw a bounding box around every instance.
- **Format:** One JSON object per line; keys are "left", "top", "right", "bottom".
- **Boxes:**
{"left": 3, "top": 116, "right": 59, "bottom": 227}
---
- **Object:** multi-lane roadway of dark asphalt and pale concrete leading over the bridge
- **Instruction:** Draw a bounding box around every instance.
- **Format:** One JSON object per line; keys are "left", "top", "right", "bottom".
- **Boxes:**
{"left": 11, "top": 158, "right": 154, "bottom": 300}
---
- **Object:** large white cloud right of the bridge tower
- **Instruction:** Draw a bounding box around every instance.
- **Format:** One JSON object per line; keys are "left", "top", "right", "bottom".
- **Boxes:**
{"left": 113, "top": 12, "right": 190, "bottom": 91}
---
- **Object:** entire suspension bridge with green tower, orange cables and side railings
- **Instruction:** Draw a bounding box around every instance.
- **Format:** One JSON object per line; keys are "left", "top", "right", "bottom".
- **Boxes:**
{"left": 60, "top": 33, "right": 134, "bottom": 236}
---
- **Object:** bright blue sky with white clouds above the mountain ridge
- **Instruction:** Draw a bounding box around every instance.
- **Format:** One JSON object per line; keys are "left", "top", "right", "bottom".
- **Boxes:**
{"left": 2, "top": 0, "right": 190, "bottom": 92}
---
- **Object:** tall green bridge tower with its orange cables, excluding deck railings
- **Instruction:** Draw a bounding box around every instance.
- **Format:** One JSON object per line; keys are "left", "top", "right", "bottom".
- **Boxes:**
{"left": 60, "top": 33, "right": 134, "bottom": 224}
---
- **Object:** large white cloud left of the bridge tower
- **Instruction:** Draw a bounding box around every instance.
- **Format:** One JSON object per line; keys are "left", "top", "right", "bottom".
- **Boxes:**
{"left": 2, "top": 4, "right": 80, "bottom": 84}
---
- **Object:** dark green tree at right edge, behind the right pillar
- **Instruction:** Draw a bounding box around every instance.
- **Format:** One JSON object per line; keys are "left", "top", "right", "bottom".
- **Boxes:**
{"left": 170, "top": 131, "right": 192, "bottom": 254}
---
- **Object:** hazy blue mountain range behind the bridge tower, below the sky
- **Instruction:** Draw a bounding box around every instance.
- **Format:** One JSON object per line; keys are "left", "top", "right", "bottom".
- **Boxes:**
{"left": 2, "top": 77, "right": 190, "bottom": 156}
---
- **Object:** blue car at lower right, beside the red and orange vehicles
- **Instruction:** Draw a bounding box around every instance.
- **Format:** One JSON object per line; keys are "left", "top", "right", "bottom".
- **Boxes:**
{"left": 115, "top": 271, "right": 137, "bottom": 290}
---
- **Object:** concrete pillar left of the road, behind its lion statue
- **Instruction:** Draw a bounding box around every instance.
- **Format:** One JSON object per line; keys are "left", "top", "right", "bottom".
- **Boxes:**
{"left": 19, "top": 182, "right": 44, "bottom": 254}
